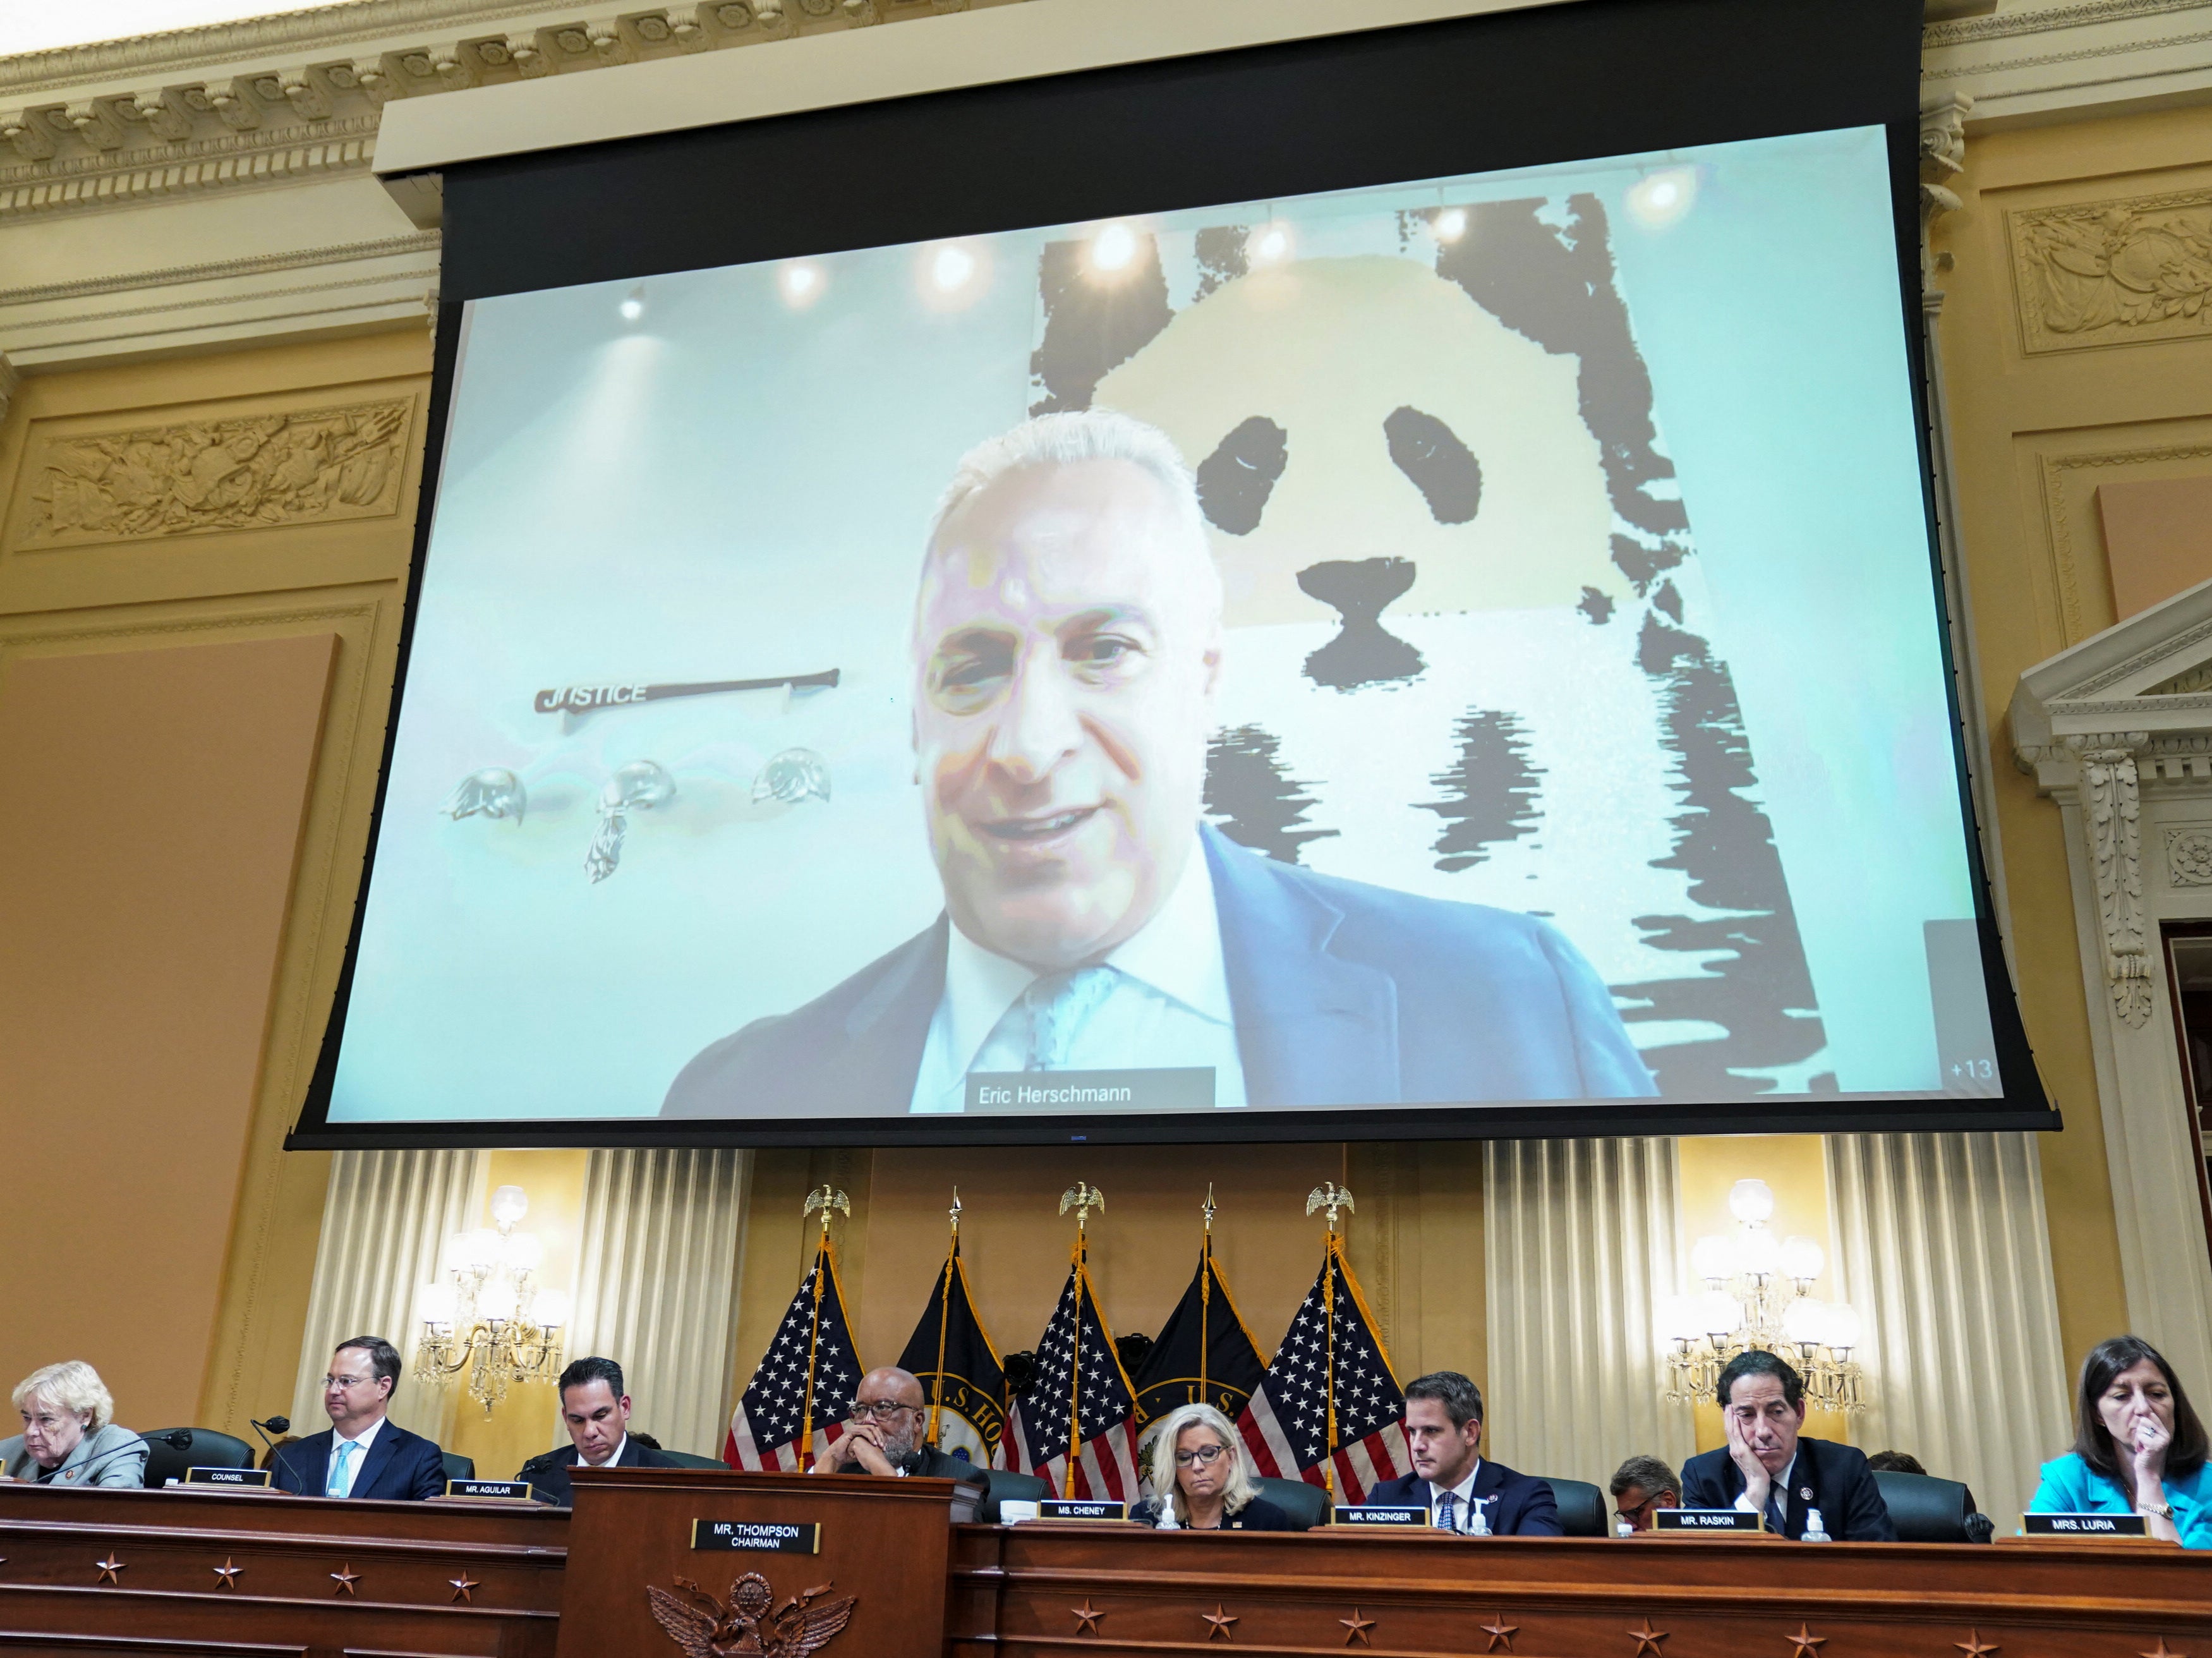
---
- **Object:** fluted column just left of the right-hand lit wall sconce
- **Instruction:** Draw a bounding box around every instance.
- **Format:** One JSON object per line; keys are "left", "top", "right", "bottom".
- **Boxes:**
{"left": 1484, "top": 1139, "right": 1696, "bottom": 1486}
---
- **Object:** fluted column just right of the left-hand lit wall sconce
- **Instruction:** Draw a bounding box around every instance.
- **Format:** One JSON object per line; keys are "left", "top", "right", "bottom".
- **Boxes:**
{"left": 566, "top": 1147, "right": 752, "bottom": 1457}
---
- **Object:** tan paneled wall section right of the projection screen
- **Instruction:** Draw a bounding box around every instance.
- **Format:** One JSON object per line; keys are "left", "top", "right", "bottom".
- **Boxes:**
{"left": 1938, "top": 111, "right": 2212, "bottom": 1362}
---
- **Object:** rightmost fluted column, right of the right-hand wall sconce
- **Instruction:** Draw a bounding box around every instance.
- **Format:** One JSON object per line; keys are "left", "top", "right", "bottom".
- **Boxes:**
{"left": 1827, "top": 1134, "right": 2072, "bottom": 1534}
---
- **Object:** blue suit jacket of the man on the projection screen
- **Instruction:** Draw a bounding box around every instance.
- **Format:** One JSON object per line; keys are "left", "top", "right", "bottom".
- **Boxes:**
{"left": 662, "top": 825, "right": 1659, "bottom": 1116}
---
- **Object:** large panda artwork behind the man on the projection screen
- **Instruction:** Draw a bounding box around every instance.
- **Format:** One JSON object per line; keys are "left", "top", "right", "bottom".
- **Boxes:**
{"left": 1030, "top": 195, "right": 1836, "bottom": 1099}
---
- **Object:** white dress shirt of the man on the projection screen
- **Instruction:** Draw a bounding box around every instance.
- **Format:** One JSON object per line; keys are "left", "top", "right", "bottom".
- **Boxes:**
{"left": 911, "top": 842, "right": 1245, "bottom": 1112}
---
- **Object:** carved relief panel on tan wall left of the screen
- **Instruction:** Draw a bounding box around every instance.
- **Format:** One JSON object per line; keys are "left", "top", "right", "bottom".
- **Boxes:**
{"left": 11, "top": 398, "right": 414, "bottom": 550}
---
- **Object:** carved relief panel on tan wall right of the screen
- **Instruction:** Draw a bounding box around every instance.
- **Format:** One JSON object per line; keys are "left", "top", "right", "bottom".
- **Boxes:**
{"left": 2006, "top": 186, "right": 2212, "bottom": 354}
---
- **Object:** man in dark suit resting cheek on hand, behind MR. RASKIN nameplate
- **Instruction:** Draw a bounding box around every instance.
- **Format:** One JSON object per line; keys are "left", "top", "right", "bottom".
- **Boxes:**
{"left": 1681, "top": 1348, "right": 1898, "bottom": 1543}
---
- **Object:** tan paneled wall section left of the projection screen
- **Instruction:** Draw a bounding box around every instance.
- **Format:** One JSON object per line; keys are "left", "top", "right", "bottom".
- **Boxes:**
{"left": 0, "top": 329, "right": 429, "bottom": 1432}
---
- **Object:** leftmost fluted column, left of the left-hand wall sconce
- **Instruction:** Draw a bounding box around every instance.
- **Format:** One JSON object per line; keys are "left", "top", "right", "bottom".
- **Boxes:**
{"left": 292, "top": 1152, "right": 478, "bottom": 1439}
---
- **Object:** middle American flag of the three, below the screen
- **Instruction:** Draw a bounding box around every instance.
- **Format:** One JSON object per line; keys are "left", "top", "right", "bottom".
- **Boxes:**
{"left": 1002, "top": 1258, "right": 1144, "bottom": 1503}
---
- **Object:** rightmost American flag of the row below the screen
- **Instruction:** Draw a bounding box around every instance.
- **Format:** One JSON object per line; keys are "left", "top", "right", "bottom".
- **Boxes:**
{"left": 1236, "top": 1238, "right": 1413, "bottom": 1503}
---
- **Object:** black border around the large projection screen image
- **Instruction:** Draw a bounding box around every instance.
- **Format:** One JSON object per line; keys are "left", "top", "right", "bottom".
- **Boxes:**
{"left": 286, "top": 0, "right": 2062, "bottom": 1149}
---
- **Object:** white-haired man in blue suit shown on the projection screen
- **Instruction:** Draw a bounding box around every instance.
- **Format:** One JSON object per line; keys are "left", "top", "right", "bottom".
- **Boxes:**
{"left": 663, "top": 411, "right": 1657, "bottom": 1116}
